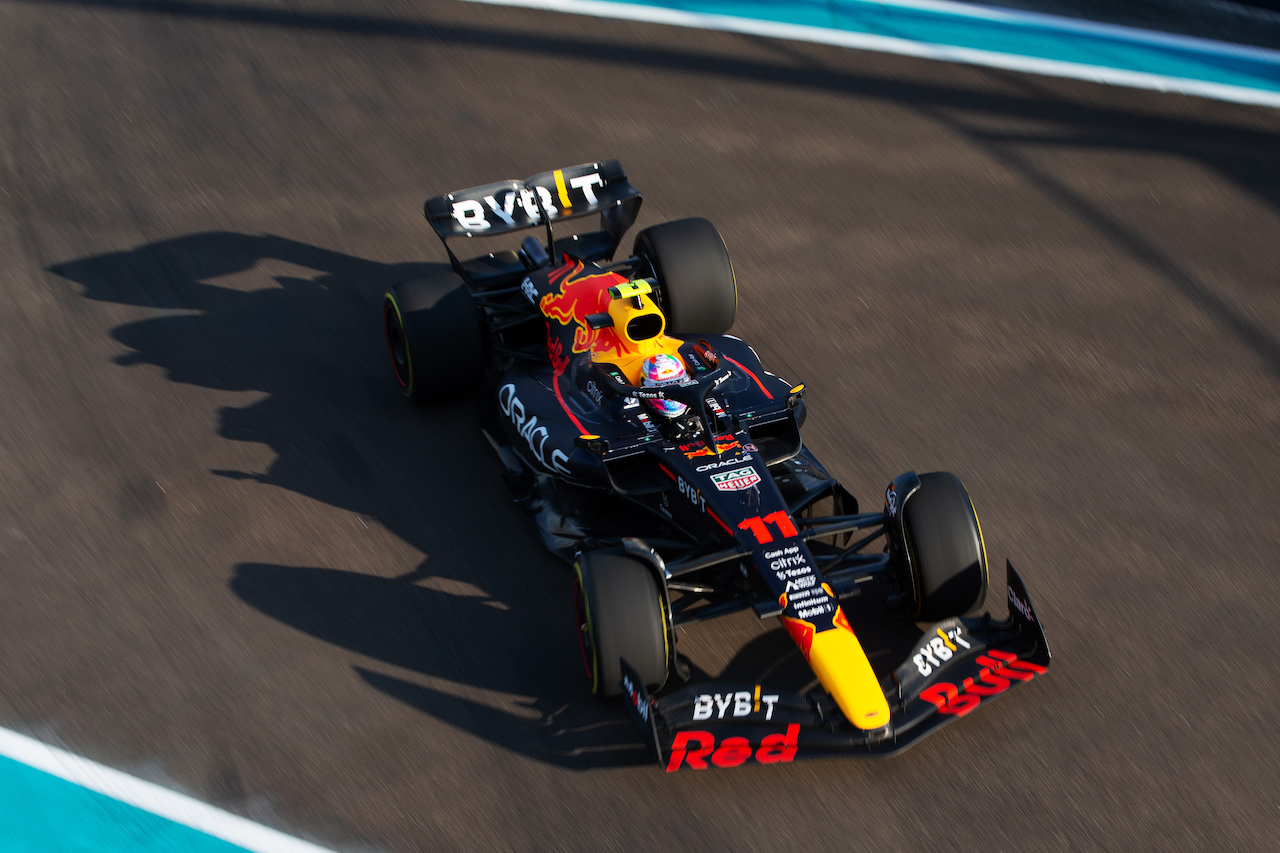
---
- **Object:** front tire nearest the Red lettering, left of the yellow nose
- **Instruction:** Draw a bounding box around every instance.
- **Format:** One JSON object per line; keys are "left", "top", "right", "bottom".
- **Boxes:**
{"left": 573, "top": 548, "right": 675, "bottom": 697}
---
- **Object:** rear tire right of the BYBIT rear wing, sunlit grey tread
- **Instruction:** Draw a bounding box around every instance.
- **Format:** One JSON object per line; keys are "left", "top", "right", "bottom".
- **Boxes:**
{"left": 631, "top": 218, "right": 737, "bottom": 337}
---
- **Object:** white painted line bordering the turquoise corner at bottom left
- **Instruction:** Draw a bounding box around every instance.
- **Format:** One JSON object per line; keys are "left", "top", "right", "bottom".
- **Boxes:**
{"left": 0, "top": 729, "right": 332, "bottom": 853}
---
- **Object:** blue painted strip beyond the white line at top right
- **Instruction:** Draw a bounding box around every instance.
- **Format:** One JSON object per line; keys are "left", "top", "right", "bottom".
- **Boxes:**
{"left": 586, "top": 0, "right": 1280, "bottom": 92}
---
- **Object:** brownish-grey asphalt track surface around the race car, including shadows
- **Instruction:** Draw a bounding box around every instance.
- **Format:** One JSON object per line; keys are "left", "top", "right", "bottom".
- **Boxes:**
{"left": 0, "top": 0, "right": 1280, "bottom": 850}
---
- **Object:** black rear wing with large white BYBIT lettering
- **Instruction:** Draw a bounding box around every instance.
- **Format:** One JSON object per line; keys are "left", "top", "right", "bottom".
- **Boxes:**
{"left": 424, "top": 160, "right": 641, "bottom": 257}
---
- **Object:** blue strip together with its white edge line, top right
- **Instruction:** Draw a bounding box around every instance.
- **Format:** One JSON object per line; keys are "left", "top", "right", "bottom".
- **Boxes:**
{"left": 467, "top": 0, "right": 1280, "bottom": 106}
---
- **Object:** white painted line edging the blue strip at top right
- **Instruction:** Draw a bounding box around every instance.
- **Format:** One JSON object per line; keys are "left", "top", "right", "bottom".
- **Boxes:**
{"left": 465, "top": 0, "right": 1280, "bottom": 106}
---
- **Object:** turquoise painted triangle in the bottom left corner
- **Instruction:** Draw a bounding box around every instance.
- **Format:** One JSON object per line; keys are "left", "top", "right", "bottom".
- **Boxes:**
{"left": 0, "top": 757, "right": 244, "bottom": 853}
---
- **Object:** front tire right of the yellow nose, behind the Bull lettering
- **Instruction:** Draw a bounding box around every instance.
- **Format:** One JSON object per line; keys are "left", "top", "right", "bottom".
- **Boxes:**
{"left": 902, "top": 471, "right": 988, "bottom": 622}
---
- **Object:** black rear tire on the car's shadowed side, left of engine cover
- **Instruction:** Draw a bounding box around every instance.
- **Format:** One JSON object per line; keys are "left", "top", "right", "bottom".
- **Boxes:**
{"left": 383, "top": 273, "right": 486, "bottom": 402}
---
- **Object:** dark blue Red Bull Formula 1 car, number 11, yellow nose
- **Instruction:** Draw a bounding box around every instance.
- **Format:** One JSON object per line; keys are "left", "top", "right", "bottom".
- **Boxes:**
{"left": 383, "top": 160, "right": 1050, "bottom": 771}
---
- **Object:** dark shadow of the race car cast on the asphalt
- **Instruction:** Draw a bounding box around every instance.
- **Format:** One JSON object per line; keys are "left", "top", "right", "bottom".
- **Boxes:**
{"left": 51, "top": 232, "right": 910, "bottom": 768}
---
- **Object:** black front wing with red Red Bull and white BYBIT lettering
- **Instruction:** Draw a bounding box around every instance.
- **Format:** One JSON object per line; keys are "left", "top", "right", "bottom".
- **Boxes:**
{"left": 622, "top": 564, "right": 1050, "bottom": 772}
